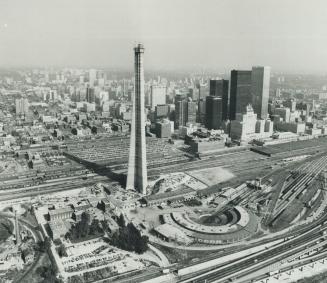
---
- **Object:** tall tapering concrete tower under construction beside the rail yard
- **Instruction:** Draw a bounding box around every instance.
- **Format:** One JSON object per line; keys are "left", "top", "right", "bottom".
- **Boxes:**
{"left": 126, "top": 44, "right": 147, "bottom": 194}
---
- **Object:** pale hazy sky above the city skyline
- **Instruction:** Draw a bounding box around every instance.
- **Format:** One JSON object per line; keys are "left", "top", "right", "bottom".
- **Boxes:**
{"left": 0, "top": 0, "right": 327, "bottom": 73}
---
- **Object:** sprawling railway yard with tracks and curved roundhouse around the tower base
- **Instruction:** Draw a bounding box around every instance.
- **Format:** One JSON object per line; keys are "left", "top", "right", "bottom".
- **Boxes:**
{"left": 0, "top": 137, "right": 327, "bottom": 282}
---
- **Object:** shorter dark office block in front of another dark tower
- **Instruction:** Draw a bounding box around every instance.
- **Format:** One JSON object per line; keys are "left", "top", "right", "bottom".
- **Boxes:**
{"left": 206, "top": 95, "right": 223, "bottom": 130}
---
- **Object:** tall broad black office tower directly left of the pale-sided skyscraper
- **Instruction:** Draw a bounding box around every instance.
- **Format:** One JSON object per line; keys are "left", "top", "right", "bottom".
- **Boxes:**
{"left": 229, "top": 70, "right": 252, "bottom": 120}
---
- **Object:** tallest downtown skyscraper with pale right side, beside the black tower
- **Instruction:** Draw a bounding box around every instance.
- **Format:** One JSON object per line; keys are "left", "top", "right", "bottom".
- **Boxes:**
{"left": 251, "top": 67, "right": 270, "bottom": 119}
